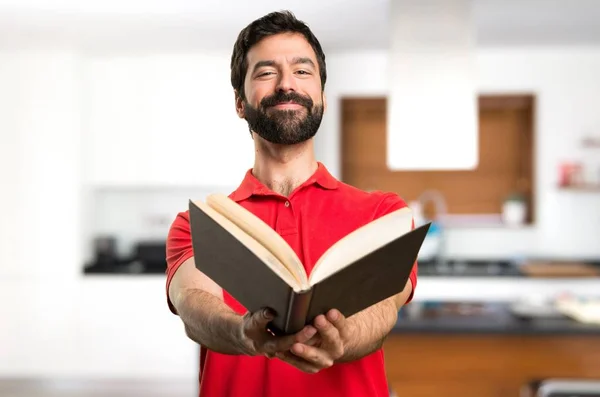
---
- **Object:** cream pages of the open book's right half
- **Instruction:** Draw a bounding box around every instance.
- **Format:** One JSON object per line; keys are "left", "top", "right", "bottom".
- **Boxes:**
{"left": 309, "top": 207, "right": 413, "bottom": 285}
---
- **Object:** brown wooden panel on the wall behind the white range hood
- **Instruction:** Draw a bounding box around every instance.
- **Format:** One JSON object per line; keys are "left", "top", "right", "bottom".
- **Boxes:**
{"left": 341, "top": 96, "right": 533, "bottom": 221}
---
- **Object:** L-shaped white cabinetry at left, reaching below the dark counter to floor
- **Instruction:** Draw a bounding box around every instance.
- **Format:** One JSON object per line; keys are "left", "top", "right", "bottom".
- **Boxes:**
{"left": 0, "top": 49, "right": 198, "bottom": 380}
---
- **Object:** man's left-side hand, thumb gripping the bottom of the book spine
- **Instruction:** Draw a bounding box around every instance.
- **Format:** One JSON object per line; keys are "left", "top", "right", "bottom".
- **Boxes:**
{"left": 239, "top": 309, "right": 317, "bottom": 358}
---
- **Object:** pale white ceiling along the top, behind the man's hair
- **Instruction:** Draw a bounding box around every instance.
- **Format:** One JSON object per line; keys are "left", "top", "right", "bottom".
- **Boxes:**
{"left": 0, "top": 0, "right": 600, "bottom": 51}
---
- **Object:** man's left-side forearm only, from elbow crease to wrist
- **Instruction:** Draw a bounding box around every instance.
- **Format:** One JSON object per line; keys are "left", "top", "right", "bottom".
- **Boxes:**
{"left": 177, "top": 289, "right": 245, "bottom": 355}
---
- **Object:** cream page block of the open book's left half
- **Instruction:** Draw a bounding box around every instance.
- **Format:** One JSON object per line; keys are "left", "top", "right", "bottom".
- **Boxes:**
{"left": 192, "top": 201, "right": 304, "bottom": 292}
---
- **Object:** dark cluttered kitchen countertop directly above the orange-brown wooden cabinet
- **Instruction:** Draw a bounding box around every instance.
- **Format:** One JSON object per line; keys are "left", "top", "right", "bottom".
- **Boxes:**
{"left": 392, "top": 302, "right": 600, "bottom": 337}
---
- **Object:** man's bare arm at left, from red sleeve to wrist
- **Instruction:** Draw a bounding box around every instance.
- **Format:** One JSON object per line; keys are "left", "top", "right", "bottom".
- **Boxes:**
{"left": 169, "top": 257, "right": 246, "bottom": 354}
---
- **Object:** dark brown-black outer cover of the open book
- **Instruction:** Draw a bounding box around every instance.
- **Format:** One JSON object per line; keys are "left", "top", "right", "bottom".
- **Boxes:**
{"left": 189, "top": 201, "right": 430, "bottom": 334}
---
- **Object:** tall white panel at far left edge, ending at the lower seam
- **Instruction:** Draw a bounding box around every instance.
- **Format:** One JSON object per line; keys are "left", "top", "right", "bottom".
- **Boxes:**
{"left": 0, "top": 52, "right": 82, "bottom": 280}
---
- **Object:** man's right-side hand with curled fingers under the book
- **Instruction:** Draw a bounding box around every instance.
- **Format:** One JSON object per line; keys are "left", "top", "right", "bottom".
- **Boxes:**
{"left": 276, "top": 310, "right": 348, "bottom": 373}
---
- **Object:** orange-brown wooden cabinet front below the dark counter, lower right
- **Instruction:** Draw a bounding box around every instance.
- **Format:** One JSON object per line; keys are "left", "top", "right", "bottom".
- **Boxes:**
{"left": 384, "top": 333, "right": 600, "bottom": 397}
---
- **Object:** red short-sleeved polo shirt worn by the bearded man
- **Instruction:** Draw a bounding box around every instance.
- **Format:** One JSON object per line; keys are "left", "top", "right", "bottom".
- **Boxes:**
{"left": 167, "top": 163, "right": 417, "bottom": 397}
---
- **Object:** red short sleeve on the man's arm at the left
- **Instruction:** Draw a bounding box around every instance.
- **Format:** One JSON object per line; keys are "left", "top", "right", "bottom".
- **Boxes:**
{"left": 166, "top": 211, "right": 194, "bottom": 314}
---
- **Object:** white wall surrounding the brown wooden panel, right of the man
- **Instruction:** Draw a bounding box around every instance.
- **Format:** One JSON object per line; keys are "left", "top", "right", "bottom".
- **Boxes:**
{"left": 318, "top": 48, "right": 600, "bottom": 257}
